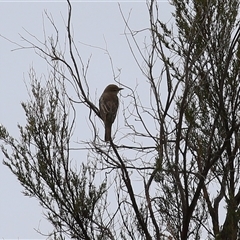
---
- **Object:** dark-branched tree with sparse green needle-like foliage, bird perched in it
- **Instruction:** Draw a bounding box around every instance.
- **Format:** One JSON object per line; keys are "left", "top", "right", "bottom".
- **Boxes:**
{"left": 0, "top": 0, "right": 240, "bottom": 240}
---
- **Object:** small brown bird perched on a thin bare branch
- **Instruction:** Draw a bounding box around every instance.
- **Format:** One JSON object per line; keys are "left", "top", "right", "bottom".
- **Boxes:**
{"left": 99, "top": 84, "right": 123, "bottom": 142}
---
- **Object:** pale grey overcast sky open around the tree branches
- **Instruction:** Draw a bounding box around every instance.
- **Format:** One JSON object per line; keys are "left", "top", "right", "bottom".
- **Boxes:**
{"left": 0, "top": 1, "right": 170, "bottom": 239}
